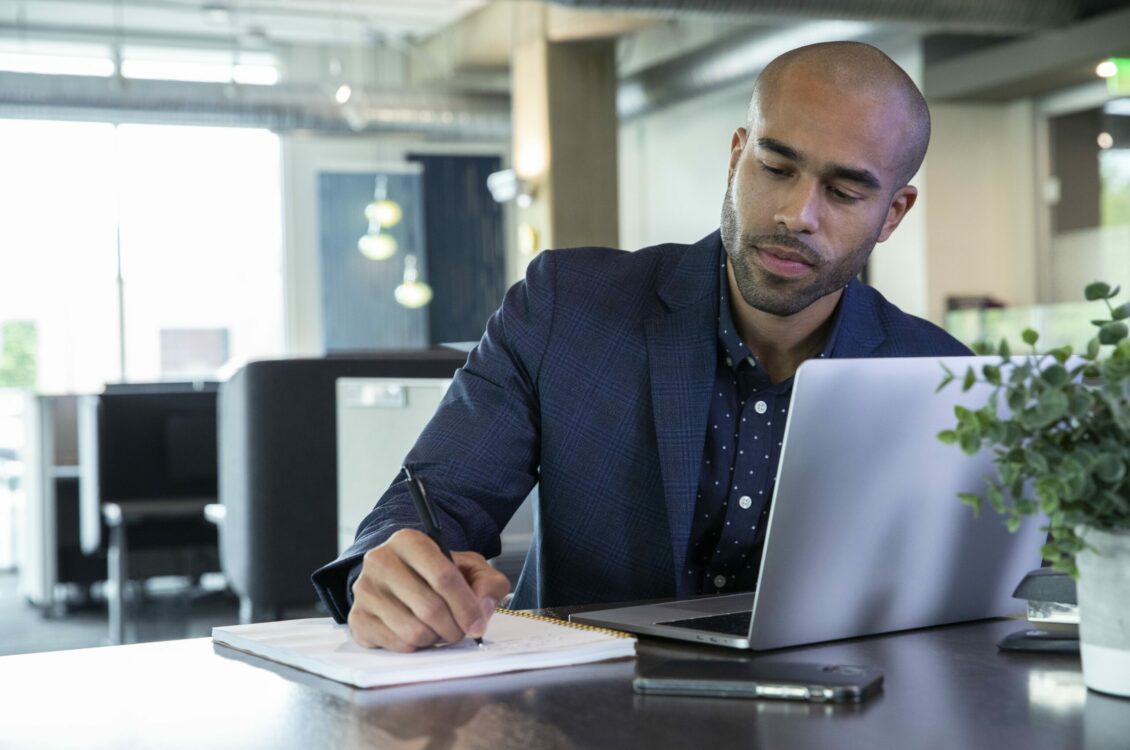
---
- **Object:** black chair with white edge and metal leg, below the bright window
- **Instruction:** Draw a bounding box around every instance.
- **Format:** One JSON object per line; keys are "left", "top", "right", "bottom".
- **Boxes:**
{"left": 79, "top": 383, "right": 219, "bottom": 643}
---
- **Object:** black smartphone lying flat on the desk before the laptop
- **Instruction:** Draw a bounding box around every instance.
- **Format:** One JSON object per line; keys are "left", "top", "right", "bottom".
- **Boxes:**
{"left": 632, "top": 659, "right": 883, "bottom": 703}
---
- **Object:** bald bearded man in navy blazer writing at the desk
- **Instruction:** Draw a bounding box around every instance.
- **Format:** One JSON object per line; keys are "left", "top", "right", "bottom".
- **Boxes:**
{"left": 314, "top": 43, "right": 968, "bottom": 651}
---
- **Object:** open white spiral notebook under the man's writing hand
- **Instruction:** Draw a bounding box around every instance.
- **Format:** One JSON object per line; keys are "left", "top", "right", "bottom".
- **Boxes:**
{"left": 212, "top": 610, "right": 636, "bottom": 688}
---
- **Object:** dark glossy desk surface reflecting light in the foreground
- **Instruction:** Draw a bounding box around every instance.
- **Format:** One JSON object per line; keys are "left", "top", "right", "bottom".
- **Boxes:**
{"left": 0, "top": 621, "right": 1130, "bottom": 750}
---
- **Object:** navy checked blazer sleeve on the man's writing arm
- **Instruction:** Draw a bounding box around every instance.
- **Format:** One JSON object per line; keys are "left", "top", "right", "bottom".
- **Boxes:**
{"left": 312, "top": 251, "right": 555, "bottom": 622}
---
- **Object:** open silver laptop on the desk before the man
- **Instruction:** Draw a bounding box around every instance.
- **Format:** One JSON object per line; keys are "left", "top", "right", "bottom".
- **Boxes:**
{"left": 570, "top": 357, "right": 1046, "bottom": 651}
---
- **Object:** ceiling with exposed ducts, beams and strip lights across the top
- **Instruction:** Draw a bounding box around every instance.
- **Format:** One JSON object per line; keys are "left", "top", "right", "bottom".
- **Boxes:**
{"left": 0, "top": 0, "right": 1130, "bottom": 137}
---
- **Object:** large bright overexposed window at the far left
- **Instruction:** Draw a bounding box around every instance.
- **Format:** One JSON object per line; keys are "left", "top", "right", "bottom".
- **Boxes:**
{"left": 0, "top": 120, "right": 284, "bottom": 392}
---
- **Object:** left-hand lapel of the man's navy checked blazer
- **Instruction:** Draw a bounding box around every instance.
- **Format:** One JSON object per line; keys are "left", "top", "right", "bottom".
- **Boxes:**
{"left": 645, "top": 232, "right": 721, "bottom": 595}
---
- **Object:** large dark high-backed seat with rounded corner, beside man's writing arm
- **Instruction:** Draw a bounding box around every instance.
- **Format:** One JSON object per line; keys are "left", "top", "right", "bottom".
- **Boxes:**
{"left": 214, "top": 348, "right": 467, "bottom": 622}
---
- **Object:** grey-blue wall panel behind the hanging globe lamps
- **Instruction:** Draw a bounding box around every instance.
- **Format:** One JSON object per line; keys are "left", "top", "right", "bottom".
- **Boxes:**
{"left": 318, "top": 172, "right": 428, "bottom": 352}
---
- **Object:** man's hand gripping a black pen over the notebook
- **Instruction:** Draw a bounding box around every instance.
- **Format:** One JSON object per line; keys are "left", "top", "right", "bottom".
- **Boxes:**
{"left": 349, "top": 529, "right": 510, "bottom": 652}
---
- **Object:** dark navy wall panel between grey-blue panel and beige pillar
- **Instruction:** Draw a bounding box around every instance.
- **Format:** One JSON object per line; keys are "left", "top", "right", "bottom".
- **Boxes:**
{"left": 408, "top": 154, "right": 506, "bottom": 343}
